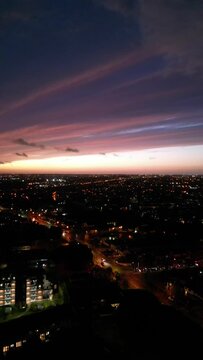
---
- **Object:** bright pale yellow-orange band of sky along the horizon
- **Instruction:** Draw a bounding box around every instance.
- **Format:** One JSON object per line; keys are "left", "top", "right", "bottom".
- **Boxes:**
{"left": 0, "top": 146, "right": 203, "bottom": 174}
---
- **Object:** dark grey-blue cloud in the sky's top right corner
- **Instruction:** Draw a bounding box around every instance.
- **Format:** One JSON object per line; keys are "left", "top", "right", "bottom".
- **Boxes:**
{"left": 95, "top": 0, "right": 203, "bottom": 74}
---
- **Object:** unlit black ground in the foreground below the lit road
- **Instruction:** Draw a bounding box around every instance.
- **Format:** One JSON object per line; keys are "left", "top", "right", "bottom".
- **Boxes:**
{"left": 0, "top": 289, "right": 203, "bottom": 359}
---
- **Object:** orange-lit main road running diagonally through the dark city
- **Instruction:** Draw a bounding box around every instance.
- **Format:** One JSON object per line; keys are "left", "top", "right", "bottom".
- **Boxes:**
{"left": 24, "top": 212, "right": 203, "bottom": 327}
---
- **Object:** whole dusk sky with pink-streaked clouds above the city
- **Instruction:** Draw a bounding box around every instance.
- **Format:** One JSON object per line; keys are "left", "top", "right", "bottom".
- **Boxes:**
{"left": 0, "top": 0, "right": 203, "bottom": 174}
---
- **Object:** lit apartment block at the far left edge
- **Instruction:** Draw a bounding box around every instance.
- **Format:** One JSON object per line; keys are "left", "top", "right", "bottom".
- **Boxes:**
{"left": 0, "top": 276, "right": 16, "bottom": 306}
